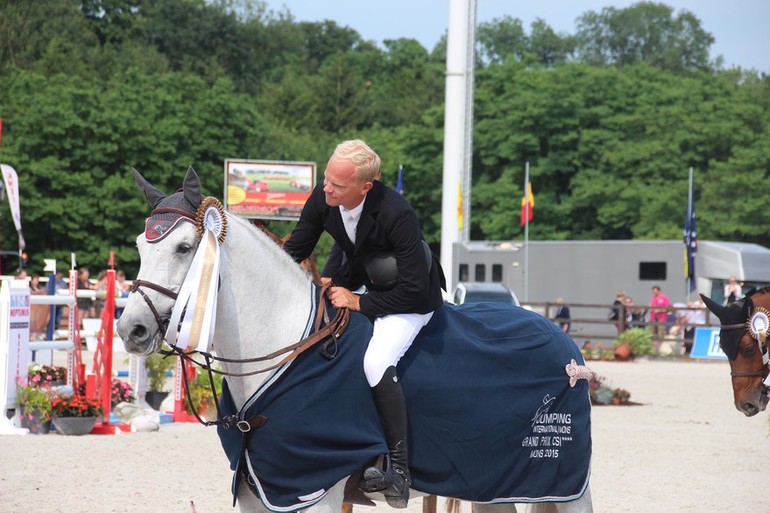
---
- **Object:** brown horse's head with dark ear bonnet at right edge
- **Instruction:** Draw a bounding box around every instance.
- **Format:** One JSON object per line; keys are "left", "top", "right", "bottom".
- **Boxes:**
{"left": 701, "top": 289, "right": 770, "bottom": 417}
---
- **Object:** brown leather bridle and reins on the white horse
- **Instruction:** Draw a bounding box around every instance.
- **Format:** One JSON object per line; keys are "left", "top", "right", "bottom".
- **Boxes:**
{"left": 129, "top": 206, "right": 350, "bottom": 432}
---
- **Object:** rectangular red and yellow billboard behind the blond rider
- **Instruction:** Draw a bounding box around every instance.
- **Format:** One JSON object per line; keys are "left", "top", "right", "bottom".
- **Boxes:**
{"left": 224, "top": 160, "right": 315, "bottom": 221}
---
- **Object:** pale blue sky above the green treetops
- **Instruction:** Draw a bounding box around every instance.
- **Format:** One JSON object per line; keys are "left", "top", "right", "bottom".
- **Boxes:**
{"left": 266, "top": 0, "right": 770, "bottom": 73}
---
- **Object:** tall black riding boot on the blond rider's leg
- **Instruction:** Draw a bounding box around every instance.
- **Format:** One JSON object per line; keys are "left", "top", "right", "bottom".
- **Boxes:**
{"left": 358, "top": 367, "right": 412, "bottom": 509}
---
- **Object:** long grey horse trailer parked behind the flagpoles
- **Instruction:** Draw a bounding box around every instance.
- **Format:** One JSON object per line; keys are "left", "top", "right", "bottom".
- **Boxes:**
{"left": 452, "top": 240, "right": 770, "bottom": 305}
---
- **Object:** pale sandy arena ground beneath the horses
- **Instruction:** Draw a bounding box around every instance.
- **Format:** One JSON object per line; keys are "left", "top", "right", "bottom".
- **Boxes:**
{"left": 0, "top": 360, "right": 770, "bottom": 513}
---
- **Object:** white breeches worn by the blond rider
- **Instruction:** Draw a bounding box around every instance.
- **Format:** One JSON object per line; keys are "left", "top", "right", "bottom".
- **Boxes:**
{"left": 364, "top": 312, "right": 433, "bottom": 387}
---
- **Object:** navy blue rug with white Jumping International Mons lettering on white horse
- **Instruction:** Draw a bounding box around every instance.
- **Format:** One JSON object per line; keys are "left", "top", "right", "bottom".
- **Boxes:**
{"left": 219, "top": 303, "right": 591, "bottom": 511}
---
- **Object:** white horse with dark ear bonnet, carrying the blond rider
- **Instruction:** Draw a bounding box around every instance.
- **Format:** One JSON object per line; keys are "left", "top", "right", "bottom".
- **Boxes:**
{"left": 117, "top": 168, "right": 593, "bottom": 513}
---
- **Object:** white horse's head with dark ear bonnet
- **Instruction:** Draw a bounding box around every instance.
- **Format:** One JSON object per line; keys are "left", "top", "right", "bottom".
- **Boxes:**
{"left": 117, "top": 167, "right": 203, "bottom": 355}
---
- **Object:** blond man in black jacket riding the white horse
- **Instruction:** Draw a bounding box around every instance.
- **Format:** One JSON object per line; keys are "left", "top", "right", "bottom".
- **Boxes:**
{"left": 284, "top": 140, "right": 446, "bottom": 508}
